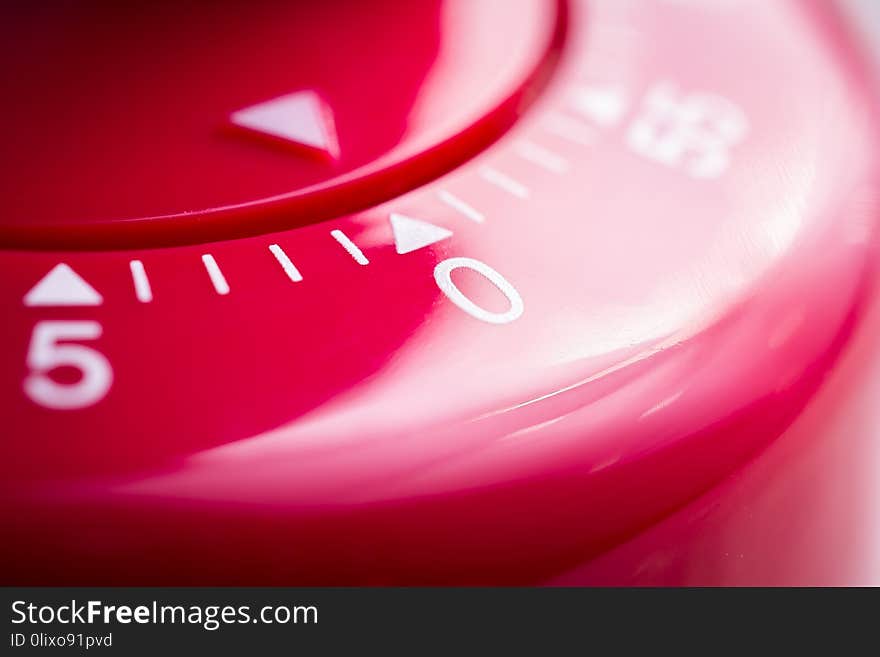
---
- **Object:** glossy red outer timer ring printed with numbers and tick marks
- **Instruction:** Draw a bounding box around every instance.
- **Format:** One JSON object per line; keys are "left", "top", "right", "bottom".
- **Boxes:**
{"left": 0, "top": 0, "right": 878, "bottom": 584}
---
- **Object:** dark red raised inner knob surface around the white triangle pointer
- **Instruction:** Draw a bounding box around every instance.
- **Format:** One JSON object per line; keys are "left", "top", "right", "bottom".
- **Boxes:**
{"left": 0, "top": 0, "right": 564, "bottom": 248}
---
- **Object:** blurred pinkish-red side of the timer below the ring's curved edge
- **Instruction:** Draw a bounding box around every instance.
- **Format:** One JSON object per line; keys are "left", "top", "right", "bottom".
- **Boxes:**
{"left": 549, "top": 258, "right": 880, "bottom": 586}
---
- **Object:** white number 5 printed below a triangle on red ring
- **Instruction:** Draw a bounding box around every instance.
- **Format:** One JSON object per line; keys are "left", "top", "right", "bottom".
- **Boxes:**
{"left": 24, "top": 321, "right": 113, "bottom": 410}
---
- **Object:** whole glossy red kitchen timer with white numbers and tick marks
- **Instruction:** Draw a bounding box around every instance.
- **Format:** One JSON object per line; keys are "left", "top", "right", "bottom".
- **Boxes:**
{"left": 0, "top": 0, "right": 880, "bottom": 584}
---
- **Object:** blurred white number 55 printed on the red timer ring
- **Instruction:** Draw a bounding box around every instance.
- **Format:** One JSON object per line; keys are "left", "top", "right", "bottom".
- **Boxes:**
{"left": 627, "top": 82, "right": 749, "bottom": 178}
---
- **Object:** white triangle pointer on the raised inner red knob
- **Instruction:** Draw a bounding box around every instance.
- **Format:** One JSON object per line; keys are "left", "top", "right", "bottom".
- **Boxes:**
{"left": 230, "top": 91, "right": 339, "bottom": 158}
